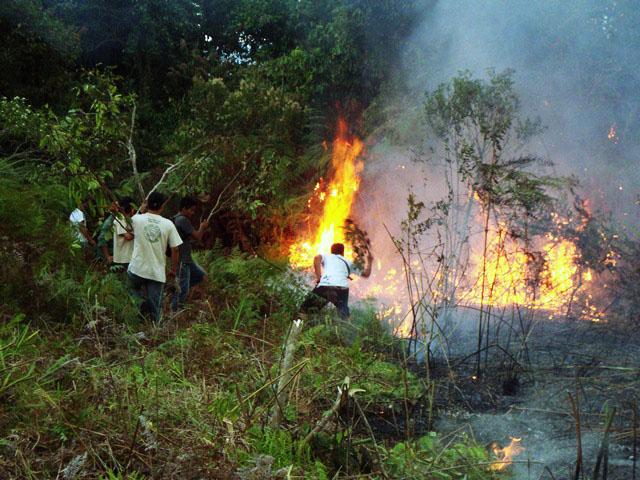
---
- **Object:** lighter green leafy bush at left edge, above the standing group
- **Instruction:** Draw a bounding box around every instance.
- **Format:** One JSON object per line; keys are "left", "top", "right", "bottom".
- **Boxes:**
{"left": 0, "top": 72, "right": 133, "bottom": 213}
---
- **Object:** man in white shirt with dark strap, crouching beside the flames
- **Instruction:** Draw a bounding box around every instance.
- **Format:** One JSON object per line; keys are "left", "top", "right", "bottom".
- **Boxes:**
{"left": 300, "top": 243, "right": 373, "bottom": 318}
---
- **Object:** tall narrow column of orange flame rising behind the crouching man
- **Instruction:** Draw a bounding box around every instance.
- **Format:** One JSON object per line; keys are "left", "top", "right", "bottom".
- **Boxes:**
{"left": 289, "top": 120, "right": 364, "bottom": 267}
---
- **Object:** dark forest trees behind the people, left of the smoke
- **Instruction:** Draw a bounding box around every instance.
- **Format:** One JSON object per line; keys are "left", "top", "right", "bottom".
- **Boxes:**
{"left": 0, "top": 0, "right": 431, "bottom": 251}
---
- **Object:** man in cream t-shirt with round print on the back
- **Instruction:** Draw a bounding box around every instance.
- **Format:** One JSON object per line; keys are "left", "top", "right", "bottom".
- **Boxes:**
{"left": 128, "top": 192, "right": 182, "bottom": 323}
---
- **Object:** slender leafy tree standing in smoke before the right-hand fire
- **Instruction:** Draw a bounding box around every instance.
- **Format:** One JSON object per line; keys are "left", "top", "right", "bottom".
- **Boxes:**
{"left": 425, "top": 71, "right": 564, "bottom": 376}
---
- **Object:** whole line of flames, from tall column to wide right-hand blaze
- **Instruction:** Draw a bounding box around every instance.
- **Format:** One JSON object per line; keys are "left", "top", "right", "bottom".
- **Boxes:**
{"left": 289, "top": 120, "right": 604, "bottom": 328}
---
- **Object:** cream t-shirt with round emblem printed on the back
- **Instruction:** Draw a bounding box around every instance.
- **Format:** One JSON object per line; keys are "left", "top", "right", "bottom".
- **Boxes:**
{"left": 129, "top": 213, "right": 182, "bottom": 283}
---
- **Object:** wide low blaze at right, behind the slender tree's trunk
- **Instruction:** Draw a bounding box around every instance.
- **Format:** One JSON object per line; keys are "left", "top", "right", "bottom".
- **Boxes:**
{"left": 466, "top": 225, "right": 592, "bottom": 311}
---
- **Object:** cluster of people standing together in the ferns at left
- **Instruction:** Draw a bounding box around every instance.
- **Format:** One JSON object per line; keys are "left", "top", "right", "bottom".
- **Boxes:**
{"left": 69, "top": 192, "right": 209, "bottom": 323}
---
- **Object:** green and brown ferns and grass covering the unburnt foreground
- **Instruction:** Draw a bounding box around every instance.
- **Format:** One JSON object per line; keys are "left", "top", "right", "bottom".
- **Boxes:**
{"left": 0, "top": 250, "right": 512, "bottom": 480}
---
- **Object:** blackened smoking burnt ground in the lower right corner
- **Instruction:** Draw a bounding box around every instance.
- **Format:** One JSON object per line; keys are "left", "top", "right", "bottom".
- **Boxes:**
{"left": 432, "top": 319, "right": 640, "bottom": 480}
